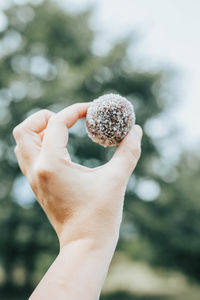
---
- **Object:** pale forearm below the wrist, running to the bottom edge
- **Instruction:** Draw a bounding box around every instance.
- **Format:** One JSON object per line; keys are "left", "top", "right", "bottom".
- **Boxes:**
{"left": 30, "top": 236, "right": 118, "bottom": 300}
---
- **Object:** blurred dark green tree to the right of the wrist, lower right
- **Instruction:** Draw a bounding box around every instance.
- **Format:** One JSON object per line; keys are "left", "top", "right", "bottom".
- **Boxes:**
{"left": 122, "top": 152, "right": 200, "bottom": 281}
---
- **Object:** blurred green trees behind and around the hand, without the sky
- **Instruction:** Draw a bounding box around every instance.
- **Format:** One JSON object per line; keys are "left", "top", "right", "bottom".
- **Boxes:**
{"left": 0, "top": 1, "right": 200, "bottom": 300}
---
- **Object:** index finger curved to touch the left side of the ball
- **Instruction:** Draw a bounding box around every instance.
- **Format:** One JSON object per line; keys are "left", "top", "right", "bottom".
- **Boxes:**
{"left": 42, "top": 102, "right": 90, "bottom": 155}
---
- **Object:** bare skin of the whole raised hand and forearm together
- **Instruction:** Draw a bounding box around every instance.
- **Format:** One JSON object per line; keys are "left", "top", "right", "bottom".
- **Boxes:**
{"left": 13, "top": 103, "right": 142, "bottom": 300}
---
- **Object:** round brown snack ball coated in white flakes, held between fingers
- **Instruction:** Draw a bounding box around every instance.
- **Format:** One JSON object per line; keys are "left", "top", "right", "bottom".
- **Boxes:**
{"left": 86, "top": 94, "right": 135, "bottom": 147}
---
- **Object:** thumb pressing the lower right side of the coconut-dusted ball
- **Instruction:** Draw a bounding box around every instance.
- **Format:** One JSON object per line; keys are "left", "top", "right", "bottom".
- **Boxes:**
{"left": 109, "top": 125, "right": 142, "bottom": 179}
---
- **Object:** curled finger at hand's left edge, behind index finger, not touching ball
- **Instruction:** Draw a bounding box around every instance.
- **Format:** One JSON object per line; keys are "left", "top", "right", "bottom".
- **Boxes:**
{"left": 13, "top": 109, "right": 54, "bottom": 169}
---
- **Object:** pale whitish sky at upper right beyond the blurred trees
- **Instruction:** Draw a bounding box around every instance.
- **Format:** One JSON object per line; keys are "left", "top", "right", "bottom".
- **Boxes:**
{"left": 59, "top": 0, "right": 200, "bottom": 148}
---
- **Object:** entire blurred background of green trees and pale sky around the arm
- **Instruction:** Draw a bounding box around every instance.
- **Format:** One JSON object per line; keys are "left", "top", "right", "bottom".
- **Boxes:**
{"left": 0, "top": 0, "right": 200, "bottom": 300}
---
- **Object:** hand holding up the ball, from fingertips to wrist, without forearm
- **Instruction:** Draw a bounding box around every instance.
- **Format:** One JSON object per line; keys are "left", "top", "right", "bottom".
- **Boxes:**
{"left": 13, "top": 103, "right": 142, "bottom": 248}
